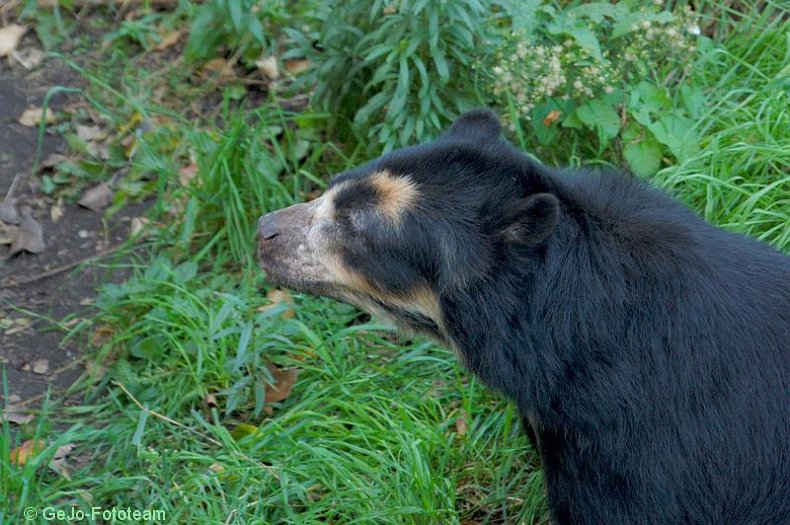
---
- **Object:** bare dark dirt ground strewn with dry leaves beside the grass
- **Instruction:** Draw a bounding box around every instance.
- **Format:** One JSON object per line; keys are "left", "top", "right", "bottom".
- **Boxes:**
{"left": 0, "top": 47, "right": 144, "bottom": 407}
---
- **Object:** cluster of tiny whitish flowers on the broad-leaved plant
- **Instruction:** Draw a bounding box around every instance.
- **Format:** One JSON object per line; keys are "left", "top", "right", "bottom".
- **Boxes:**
{"left": 488, "top": 3, "right": 700, "bottom": 120}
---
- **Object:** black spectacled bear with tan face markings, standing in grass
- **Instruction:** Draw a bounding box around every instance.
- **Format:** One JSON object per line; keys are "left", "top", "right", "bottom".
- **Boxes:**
{"left": 258, "top": 109, "right": 790, "bottom": 525}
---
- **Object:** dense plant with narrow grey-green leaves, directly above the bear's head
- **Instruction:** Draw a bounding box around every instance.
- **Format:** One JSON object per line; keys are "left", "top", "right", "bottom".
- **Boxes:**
{"left": 287, "top": 0, "right": 502, "bottom": 151}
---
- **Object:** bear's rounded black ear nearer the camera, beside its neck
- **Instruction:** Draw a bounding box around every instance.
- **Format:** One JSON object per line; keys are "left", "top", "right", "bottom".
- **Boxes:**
{"left": 503, "top": 193, "right": 560, "bottom": 245}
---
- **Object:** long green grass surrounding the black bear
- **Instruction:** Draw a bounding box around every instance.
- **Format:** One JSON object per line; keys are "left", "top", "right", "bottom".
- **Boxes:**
{"left": 0, "top": 2, "right": 790, "bottom": 523}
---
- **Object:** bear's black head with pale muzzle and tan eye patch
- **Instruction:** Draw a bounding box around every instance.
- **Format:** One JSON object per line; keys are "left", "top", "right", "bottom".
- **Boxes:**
{"left": 258, "top": 109, "right": 560, "bottom": 342}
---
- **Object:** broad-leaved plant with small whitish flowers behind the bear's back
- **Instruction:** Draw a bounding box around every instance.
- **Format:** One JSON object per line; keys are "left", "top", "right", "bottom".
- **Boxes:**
{"left": 484, "top": 2, "right": 705, "bottom": 176}
